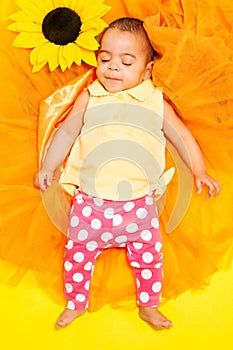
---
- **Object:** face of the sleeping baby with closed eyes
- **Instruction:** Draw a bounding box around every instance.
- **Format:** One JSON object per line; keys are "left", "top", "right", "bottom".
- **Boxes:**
{"left": 96, "top": 28, "right": 152, "bottom": 93}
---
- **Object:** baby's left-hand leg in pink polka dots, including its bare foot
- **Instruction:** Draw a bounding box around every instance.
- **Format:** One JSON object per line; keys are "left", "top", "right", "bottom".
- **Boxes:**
{"left": 56, "top": 240, "right": 102, "bottom": 327}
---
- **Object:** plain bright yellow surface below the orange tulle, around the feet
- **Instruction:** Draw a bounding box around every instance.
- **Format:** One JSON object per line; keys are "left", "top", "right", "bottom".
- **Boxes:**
{"left": 0, "top": 263, "right": 233, "bottom": 350}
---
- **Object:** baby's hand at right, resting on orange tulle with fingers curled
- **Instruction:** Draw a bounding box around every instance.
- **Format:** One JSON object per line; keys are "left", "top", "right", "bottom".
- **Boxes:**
{"left": 195, "top": 173, "right": 222, "bottom": 199}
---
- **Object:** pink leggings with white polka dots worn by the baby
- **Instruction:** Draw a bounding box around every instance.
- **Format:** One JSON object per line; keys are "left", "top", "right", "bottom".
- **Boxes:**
{"left": 64, "top": 189, "right": 162, "bottom": 310}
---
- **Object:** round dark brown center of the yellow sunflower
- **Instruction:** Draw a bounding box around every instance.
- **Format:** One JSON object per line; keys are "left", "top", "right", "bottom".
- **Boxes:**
{"left": 42, "top": 7, "right": 82, "bottom": 45}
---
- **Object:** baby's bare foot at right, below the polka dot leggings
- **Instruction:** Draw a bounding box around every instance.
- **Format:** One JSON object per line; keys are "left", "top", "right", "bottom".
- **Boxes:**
{"left": 139, "top": 306, "right": 173, "bottom": 330}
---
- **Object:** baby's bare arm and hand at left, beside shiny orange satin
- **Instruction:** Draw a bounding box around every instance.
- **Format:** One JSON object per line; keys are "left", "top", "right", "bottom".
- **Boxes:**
{"left": 34, "top": 90, "right": 89, "bottom": 191}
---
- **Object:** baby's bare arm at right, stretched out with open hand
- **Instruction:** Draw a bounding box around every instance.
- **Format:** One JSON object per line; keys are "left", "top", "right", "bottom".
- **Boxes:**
{"left": 163, "top": 101, "right": 221, "bottom": 198}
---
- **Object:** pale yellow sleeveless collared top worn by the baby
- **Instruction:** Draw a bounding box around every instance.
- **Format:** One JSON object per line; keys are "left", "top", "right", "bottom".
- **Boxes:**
{"left": 60, "top": 80, "right": 174, "bottom": 201}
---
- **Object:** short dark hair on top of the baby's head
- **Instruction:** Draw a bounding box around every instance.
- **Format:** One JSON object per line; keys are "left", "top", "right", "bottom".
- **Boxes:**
{"left": 106, "top": 17, "right": 157, "bottom": 61}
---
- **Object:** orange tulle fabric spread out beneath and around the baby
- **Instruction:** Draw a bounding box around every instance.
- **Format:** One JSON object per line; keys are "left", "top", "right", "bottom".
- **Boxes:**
{"left": 0, "top": 0, "right": 233, "bottom": 311}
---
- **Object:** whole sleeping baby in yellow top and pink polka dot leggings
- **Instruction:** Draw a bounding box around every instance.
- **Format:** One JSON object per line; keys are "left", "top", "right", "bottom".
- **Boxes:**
{"left": 36, "top": 18, "right": 221, "bottom": 329}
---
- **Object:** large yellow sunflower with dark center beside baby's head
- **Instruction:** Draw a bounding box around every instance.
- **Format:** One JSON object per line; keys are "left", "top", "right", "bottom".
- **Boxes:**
{"left": 7, "top": 0, "right": 110, "bottom": 72}
